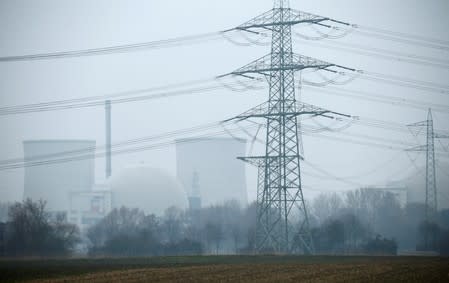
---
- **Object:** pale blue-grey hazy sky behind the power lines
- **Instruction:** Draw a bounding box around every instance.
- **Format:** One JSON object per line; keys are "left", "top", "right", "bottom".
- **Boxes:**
{"left": 0, "top": 0, "right": 449, "bottom": 206}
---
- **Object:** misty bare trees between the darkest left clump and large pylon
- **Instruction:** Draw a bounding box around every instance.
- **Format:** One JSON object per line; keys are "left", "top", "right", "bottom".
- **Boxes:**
{"left": 87, "top": 201, "right": 255, "bottom": 256}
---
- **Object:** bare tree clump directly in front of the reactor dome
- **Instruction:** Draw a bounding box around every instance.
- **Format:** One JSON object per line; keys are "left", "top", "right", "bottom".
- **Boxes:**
{"left": 87, "top": 207, "right": 202, "bottom": 256}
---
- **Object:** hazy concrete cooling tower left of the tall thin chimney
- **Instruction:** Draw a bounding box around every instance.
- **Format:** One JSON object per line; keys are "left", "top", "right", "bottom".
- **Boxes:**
{"left": 23, "top": 140, "right": 95, "bottom": 212}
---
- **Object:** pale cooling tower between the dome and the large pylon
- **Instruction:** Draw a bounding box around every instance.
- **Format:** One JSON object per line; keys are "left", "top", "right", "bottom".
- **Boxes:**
{"left": 176, "top": 138, "right": 248, "bottom": 206}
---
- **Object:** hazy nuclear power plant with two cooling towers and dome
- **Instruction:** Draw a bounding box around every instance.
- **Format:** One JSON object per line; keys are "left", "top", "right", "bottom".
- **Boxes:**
{"left": 23, "top": 136, "right": 247, "bottom": 230}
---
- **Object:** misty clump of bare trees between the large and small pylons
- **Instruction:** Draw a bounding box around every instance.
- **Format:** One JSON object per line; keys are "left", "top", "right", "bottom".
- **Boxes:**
{"left": 312, "top": 189, "right": 412, "bottom": 254}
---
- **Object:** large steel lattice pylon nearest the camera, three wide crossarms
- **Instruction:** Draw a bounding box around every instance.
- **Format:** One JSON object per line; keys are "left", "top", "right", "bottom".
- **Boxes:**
{"left": 222, "top": 0, "right": 355, "bottom": 254}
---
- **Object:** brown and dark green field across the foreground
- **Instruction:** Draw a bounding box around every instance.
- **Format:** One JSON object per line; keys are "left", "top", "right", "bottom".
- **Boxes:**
{"left": 0, "top": 256, "right": 449, "bottom": 283}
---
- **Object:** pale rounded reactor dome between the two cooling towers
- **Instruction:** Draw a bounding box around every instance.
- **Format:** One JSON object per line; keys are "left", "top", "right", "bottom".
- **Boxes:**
{"left": 109, "top": 165, "right": 187, "bottom": 215}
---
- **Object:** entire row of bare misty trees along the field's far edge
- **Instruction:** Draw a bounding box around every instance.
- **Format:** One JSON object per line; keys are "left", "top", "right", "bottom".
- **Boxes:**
{"left": 0, "top": 189, "right": 449, "bottom": 256}
